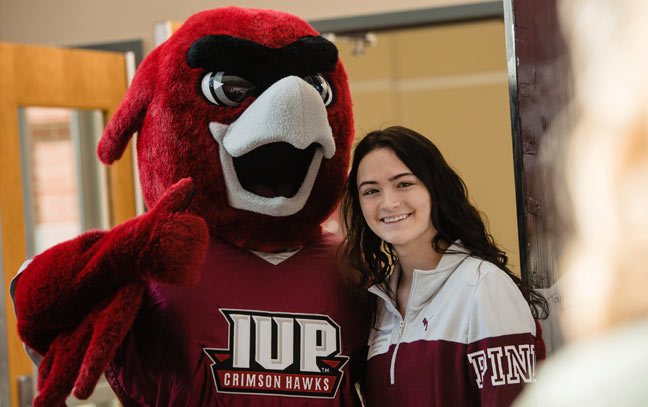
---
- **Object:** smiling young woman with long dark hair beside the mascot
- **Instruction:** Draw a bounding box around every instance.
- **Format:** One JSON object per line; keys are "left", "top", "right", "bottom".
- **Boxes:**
{"left": 340, "top": 126, "right": 547, "bottom": 407}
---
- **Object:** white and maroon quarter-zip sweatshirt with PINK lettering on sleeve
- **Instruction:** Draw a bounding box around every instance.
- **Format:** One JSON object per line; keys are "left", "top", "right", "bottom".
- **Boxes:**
{"left": 364, "top": 242, "right": 536, "bottom": 407}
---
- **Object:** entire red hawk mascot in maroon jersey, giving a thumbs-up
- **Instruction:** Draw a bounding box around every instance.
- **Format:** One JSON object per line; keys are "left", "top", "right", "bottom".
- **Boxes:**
{"left": 12, "top": 7, "right": 368, "bottom": 407}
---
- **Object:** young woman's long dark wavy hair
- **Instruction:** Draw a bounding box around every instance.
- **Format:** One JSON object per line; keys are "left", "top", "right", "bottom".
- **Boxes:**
{"left": 340, "top": 126, "right": 548, "bottom": 319}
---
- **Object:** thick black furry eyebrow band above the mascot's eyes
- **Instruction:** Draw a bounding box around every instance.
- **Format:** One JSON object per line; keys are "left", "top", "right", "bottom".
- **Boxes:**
{"left": 187, "top": 34, "right": 338, "bottom": 79}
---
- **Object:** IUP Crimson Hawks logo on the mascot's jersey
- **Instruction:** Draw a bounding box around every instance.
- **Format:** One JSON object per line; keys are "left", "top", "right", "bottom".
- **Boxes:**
{"left": 203, "top": 309, "right": 349, "bottom": 398}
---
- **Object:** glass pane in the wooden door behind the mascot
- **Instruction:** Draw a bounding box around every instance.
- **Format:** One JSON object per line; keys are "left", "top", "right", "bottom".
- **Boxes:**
{"left": 19, "top": 107, "right": 108, "bottom": 257}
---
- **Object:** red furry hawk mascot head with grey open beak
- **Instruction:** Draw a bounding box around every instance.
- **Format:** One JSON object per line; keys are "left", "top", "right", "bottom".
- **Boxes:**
{"left": 98, "top": 7, "right": 353, "bottom": 251}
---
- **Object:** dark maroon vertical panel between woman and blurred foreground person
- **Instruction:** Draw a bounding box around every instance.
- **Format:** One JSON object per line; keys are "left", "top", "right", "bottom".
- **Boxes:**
{"left": 504, "top": 0, "right": 573, "bottom": 288}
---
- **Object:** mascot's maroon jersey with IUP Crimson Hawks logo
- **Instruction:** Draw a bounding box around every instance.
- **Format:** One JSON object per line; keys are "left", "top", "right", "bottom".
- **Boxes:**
{"left": 106, "top": 233, "right": 366, "bottom": 407}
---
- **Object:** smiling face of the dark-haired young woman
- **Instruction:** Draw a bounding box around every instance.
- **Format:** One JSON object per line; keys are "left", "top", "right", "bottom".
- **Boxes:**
{"left": 357, "top": 147, "right": 436, "bottom": 253}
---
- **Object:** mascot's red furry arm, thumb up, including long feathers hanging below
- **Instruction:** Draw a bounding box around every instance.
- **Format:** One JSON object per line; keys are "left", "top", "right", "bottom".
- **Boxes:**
{"left": 16, "top": 179, "right": 209, "bottom": 406}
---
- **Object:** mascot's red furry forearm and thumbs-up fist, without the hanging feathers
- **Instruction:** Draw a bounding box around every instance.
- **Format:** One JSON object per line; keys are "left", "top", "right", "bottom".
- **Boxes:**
{"left": 16, "top": 179, "right": 208, "bottom": 354}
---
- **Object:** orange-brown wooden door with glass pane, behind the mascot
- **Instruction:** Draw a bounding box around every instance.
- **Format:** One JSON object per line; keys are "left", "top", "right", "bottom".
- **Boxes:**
{"left": 0, "top": 43, "right": 135, "bottom": 407}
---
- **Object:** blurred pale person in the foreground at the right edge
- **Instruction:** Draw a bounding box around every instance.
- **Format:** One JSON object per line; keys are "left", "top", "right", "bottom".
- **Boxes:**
{"left": 516, "top": 0, "right": 648, "bottom": 406}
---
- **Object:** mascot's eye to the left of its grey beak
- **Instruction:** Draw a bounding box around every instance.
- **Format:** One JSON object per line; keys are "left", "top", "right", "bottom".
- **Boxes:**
{"left": 200, "top": 72, "right": 254, "bottom": 107}
